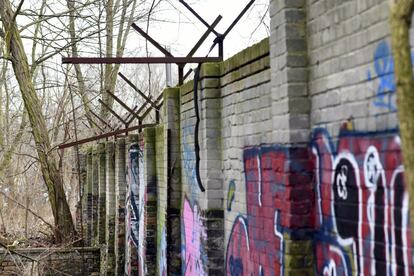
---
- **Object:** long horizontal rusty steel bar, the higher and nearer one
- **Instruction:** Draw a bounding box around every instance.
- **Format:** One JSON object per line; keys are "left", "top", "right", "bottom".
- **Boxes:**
{"left": 62, "top": 57, "right": 222, "bottom": 64}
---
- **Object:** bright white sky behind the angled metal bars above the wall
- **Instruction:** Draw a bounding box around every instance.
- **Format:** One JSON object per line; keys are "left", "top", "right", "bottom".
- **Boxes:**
{"left": 128, "top": 0, "right": 269, "bottom": 58}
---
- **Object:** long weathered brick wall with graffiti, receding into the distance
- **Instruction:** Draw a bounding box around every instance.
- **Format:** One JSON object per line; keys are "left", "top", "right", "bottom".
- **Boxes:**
{"left": 78, "top": 0, "right": 413, "bottom": 275}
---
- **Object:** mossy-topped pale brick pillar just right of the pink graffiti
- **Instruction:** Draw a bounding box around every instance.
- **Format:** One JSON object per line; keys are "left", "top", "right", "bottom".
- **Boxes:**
{"left": 198, "top": 63, "right": 225, "bottom": 275}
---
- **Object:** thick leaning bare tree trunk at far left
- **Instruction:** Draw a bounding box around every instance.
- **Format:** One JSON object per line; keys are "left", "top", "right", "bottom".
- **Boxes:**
{"left": 0, "top": 0, "right": 75, "bottom": 242}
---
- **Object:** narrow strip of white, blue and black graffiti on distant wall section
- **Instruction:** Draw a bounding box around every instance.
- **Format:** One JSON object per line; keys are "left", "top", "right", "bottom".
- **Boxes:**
{"left": 125, "top": 145, "right": 146, "bottom": 275}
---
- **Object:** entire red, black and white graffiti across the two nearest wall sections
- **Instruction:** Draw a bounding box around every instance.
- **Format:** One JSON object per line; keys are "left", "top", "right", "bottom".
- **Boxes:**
{"left": 226, "top": 126, "right": 413, "bottom": 275}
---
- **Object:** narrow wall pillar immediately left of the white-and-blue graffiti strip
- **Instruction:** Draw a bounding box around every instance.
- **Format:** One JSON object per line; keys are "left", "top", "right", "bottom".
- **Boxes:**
{"left": 115, "top": 138, "right": 126, "bottom": 275}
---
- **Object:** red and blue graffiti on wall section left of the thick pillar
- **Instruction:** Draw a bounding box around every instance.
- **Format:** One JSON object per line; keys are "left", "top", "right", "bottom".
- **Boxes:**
{"left": 226, "top": 146, "right": 311, "bottom": 276}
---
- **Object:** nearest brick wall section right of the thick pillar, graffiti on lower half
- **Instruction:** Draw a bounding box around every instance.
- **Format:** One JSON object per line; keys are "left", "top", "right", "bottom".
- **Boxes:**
{"left": 304, "top": 1, "right": 413, "bottom": 275}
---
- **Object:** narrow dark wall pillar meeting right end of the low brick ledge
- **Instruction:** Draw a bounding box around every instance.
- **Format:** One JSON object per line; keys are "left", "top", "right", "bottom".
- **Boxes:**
{"left": 98, "top": 143, "right": 106, "bottom": 244}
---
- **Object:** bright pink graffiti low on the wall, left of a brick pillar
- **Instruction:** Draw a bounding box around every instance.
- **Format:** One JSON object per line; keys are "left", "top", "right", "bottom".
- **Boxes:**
{"left": 181, "top": 198, "right": 207, "bottom": 276}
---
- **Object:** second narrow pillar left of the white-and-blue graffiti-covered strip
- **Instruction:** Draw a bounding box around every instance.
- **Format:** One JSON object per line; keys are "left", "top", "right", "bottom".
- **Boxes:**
{"left": 104, "top": 141, "right": 116, "bottom": 275}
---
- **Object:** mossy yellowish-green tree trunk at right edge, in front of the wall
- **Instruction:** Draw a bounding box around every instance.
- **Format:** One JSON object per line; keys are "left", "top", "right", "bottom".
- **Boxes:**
{"left": 390, "top": 0, "right": 414, "bottom": 246}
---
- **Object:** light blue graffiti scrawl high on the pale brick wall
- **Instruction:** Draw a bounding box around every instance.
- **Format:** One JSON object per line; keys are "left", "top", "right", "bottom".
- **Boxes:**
{"left": 367, "top": 41, "right": 414, "bottom": 112}
